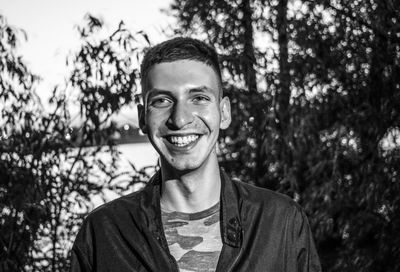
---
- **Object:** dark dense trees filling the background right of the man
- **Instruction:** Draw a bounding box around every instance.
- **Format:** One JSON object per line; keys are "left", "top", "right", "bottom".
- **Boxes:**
{"left": 166, "top": 0, "right": 400, "bottom": 271}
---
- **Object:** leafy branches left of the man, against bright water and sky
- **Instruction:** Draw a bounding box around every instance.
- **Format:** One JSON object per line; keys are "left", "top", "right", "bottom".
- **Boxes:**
{"left": 0, "top": 15, "right": 153, "bottom": 271}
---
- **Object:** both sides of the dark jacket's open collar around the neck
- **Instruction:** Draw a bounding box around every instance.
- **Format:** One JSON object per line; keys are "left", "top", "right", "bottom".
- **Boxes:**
{"left": 142, "top": 169, "right": 243, "bottom": 248}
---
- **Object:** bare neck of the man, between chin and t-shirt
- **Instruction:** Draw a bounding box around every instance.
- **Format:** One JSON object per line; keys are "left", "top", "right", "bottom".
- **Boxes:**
{"left": 161, "top": 154, "right": 221, "bottom": 213}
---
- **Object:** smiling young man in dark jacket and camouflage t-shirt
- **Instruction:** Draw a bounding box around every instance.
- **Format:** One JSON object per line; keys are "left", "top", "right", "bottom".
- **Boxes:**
{"left": 71, "top": 38, "right": 320, "bottom": 272}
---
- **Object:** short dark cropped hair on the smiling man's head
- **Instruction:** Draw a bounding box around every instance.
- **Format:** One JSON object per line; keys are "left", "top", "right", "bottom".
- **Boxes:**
{"left": 140, "top": 37, "right": 222, "bottom": 91}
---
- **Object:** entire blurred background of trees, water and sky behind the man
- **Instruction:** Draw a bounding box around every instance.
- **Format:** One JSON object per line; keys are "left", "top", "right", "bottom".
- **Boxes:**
{"left": 0, "top": 0, "right": 400, "bottom": 271}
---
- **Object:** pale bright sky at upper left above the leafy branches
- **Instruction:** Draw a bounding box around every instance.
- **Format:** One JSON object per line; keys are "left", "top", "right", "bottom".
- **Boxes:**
{"left": 0, "top": 0, "right": 174, "bottom": 123}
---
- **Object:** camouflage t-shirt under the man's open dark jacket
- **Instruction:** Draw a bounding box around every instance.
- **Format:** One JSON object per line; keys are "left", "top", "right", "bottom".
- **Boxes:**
{"left": 161, "top": 203, "right": 222, "bottom": 272}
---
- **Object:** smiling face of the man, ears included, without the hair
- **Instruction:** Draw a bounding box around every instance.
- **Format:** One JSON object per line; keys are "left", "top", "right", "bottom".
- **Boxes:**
{"left": 139, "top": 60, "right": 231, "bottom": 171}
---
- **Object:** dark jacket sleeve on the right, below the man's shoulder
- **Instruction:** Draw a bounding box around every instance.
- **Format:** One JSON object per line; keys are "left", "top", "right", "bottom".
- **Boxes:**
{"left": 293, "top": 207, "right": 321, "bottom": 272}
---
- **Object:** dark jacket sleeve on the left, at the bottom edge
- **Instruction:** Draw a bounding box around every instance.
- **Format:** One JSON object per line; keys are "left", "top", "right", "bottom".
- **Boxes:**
{"left": 70, "top": 222, "right": 93, "bottom": 272}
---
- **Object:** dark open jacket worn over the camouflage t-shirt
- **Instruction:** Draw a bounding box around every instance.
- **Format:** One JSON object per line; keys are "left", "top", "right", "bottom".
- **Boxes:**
{"left": 71, "top": 173, "right": 321, "bottom": 272}
